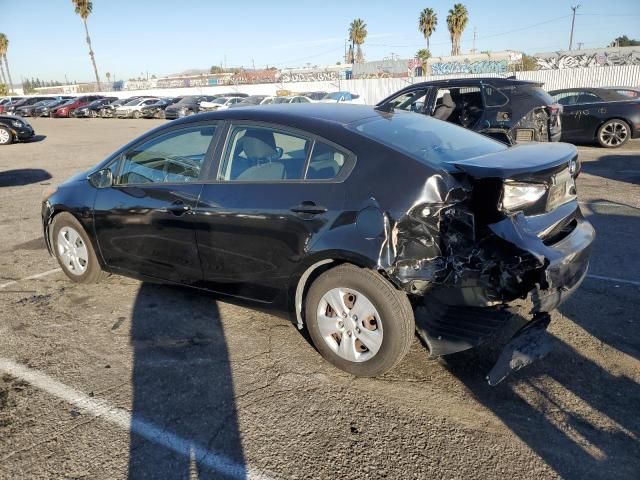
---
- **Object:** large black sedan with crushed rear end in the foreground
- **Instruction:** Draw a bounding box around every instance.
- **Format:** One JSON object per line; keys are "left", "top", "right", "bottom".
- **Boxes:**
{"left": 42, "top": 104, "right": 594, "bottom": 384}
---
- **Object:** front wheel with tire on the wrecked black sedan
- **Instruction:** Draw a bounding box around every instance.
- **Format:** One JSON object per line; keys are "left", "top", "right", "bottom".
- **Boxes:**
{"left": 50, "top": 212, "right": 108, "bottom": 283}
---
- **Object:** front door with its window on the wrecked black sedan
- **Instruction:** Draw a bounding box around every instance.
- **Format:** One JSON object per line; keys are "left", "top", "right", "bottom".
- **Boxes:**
{"left": 94, "top": 124, "right": 216, "bottom": 284}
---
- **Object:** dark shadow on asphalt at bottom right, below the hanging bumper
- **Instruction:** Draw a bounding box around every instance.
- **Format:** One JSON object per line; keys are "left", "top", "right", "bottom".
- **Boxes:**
{"left": 442, "top": 316, "right": 640, "bottom": 480}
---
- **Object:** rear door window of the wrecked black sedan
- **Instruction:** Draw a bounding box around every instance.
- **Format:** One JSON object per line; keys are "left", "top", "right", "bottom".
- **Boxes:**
{"left": 218, "top": 127, "right": 311, "bottom": 182}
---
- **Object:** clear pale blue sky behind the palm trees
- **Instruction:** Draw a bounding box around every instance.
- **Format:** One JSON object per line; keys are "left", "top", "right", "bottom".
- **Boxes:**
{"left": 0, "top": 0, "right": 640, "bottom": 82}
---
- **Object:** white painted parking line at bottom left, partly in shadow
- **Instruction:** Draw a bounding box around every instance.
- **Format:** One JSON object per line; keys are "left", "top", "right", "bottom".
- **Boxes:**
{"left": 0, "top": 357, "right": 273, "bottom": 480}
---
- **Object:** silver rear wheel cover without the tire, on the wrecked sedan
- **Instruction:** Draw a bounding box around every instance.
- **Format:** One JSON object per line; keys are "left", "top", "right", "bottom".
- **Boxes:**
{"left": 316, "top": 288, "right": 383, "bottom": 362}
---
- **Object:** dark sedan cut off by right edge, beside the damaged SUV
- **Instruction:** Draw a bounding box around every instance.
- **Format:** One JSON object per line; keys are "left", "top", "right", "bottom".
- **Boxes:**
{"left": 549, "top": 88, "right": 640, "bottom": 148}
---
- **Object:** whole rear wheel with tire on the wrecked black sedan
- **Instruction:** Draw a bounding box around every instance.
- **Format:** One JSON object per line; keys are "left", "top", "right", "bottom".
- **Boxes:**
{"left": 305, "top": 264, "right": 415, "bottom": 377}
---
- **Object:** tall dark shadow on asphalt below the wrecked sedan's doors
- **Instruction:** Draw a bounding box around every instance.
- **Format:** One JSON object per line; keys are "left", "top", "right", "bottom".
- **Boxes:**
{"left": 128, "top": 283, "right": 245, "bottom": 479}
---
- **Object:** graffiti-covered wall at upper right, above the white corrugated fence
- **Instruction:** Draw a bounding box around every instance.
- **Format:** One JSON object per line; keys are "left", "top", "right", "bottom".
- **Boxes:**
{"left": 534, "top": 47, "right": 640, "bottom": 70}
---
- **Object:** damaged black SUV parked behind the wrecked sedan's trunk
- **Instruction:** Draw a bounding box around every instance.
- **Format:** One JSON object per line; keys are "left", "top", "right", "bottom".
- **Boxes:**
{"left": 376, "top": 78, "right": 562, "bottom": 145}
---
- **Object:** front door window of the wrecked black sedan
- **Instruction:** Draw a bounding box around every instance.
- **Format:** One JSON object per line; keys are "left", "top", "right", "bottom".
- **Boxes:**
{"left": 117, "top": 125, "right": 215, "bottom": 185}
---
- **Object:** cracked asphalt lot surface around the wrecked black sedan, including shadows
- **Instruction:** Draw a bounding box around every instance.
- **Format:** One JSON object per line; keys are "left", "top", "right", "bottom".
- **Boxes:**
{"left": 0, "top": 119, "right": 640, "bottom": 480}
